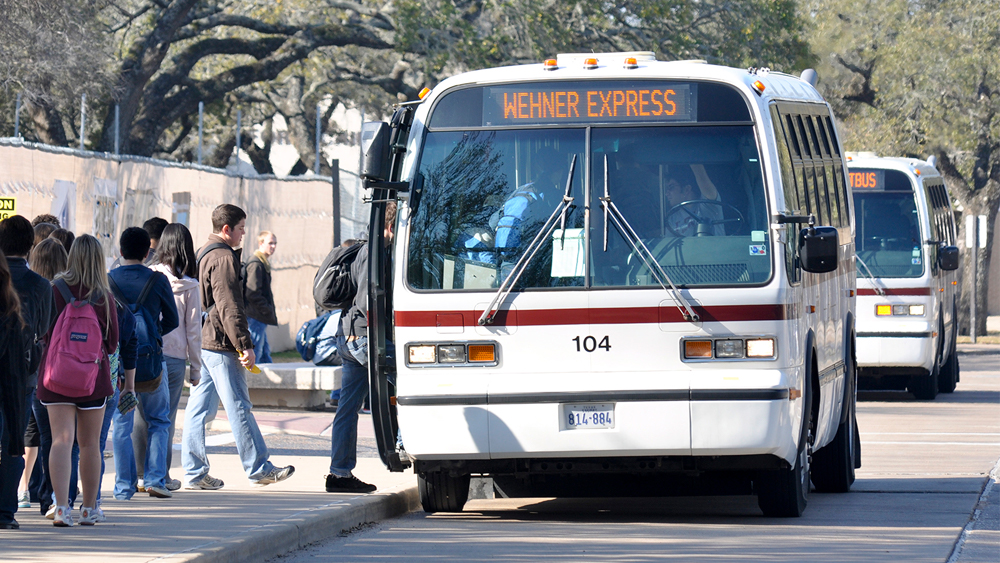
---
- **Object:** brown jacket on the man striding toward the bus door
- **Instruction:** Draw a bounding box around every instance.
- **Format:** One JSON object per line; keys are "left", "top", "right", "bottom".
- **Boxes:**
{"left": 197, "top": 234, "right": 253, "bottom": 352}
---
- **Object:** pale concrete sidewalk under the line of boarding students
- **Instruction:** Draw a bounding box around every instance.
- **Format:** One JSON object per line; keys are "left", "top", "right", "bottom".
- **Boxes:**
{"left": 0, "top": 403, "right": 419, "bottom": 563}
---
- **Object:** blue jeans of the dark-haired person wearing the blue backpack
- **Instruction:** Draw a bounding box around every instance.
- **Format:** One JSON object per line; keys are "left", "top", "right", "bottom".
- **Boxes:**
{"left": 111, "top": 368, "right": 170, "bottom": 500}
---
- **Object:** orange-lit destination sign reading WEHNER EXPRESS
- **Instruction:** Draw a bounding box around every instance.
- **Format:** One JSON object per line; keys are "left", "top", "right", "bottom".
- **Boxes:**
{"left": 483, "top": 82, "right": 698, "bottom": 126}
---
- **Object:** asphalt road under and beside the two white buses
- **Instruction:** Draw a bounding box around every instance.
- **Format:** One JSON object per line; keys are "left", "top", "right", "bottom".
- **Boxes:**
{"left": 275, "top": 353, "right": 1000, "bottom": 563}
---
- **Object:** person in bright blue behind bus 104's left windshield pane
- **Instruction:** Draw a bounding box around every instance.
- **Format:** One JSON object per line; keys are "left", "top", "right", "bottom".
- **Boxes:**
{"left": 490, "top": 147, "right": 569, "bottom": 279}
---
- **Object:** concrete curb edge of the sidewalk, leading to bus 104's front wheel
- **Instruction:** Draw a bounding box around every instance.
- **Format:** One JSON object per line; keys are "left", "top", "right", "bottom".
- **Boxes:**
{"left": 155, "top": 485, "right": 420, "bottom": 563}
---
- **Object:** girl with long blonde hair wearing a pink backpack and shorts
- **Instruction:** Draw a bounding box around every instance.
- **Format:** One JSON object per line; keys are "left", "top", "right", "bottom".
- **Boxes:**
{"left": 37, "top": 235, "right": 118, "bottom": 526}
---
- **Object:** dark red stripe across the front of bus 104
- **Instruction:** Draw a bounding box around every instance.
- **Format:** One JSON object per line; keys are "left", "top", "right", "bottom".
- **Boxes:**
{"left": 395, "top": 305, "right": 796, "bottom": 327}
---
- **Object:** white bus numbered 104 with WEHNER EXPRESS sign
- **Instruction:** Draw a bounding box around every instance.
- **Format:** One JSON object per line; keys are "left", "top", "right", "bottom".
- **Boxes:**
{"left": 362, "top": 53, "right": 860, "bottom": 516}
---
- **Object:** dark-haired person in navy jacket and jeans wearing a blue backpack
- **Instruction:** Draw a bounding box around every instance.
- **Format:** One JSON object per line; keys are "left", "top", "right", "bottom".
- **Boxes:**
{"left": 108, "top": 227, "right": 179, "bottom": 500}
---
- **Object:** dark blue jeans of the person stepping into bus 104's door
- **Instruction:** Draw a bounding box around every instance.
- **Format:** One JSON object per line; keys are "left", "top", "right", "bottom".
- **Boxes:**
{"left": 330, "top": 334, "right": 368, "bottom": 477}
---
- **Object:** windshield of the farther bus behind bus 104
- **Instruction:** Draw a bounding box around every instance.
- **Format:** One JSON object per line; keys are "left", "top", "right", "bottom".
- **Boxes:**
{"left": 854, "top": 190, "right": 924, "bottom": 278}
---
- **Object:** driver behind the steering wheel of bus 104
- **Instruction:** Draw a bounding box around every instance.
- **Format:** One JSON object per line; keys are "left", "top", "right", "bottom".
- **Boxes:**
{"left": 664, "top": 164, "right": 726, "bottom": 237}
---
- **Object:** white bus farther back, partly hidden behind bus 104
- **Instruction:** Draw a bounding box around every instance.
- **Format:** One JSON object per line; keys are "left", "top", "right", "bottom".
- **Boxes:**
{"left": 848, "top": 153, "right": 959, "bottom": 400}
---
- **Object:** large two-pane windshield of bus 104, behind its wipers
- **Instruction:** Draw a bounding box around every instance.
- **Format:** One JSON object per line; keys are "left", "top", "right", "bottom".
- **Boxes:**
{"left": 406, "top": 125, "right": 772, "bottom": 290}
